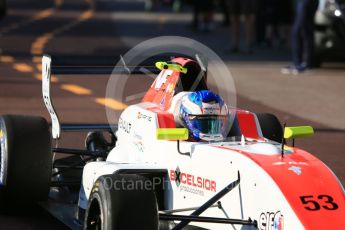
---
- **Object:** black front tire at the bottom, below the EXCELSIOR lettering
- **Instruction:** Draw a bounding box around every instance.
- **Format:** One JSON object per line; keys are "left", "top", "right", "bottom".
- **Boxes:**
{"left": 84, "top": 174, "right": 159, "bottom": 230}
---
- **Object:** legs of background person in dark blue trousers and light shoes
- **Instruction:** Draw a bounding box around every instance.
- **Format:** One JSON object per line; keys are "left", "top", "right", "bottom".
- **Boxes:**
{"left": 282, "top": 0, "right": 319, "bottom": 74}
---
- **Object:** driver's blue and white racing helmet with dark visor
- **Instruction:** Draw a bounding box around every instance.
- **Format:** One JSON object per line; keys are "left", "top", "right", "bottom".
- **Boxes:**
{"left": 179, "top": 90, "right": 228, "bottom": 141}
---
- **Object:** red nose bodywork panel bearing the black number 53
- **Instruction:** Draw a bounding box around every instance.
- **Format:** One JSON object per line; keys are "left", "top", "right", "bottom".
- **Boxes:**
{"left": 219, "top": 147, "right": 345, "bottom": 230}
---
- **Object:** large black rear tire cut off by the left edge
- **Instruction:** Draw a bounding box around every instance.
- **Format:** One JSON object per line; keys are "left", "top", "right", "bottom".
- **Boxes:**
{"left": 0, "top": 115, "right": 52, "bottom": 212}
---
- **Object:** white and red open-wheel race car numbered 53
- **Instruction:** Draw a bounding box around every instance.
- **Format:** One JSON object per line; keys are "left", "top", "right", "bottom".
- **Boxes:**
{"left": 0, "top": 56, "right": 345, "bottom": 230}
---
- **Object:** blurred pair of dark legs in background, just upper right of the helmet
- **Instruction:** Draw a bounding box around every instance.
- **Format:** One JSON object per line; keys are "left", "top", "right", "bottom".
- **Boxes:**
{"left": 229, "top": 0, "right": 257, "bottom": 54}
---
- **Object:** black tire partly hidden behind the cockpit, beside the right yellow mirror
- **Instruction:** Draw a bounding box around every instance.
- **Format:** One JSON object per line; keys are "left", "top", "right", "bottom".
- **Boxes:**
{"left": 256, "top": 113, "right": 283, "bottom": 143}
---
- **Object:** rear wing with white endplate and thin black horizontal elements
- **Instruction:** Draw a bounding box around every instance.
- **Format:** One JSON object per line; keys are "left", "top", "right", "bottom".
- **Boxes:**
{"left": 42, "top": 55, "right": 161, "bottom": 139}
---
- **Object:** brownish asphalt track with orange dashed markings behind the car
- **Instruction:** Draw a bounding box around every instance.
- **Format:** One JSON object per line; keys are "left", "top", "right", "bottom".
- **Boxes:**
{"left": 0, "top": 0, "right": 345, "bottom": 229}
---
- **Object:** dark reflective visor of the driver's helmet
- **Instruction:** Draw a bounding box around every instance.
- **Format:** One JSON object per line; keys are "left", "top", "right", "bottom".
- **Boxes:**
{"left": 188, "top": 115, "right": 226, "bottom": 134}
